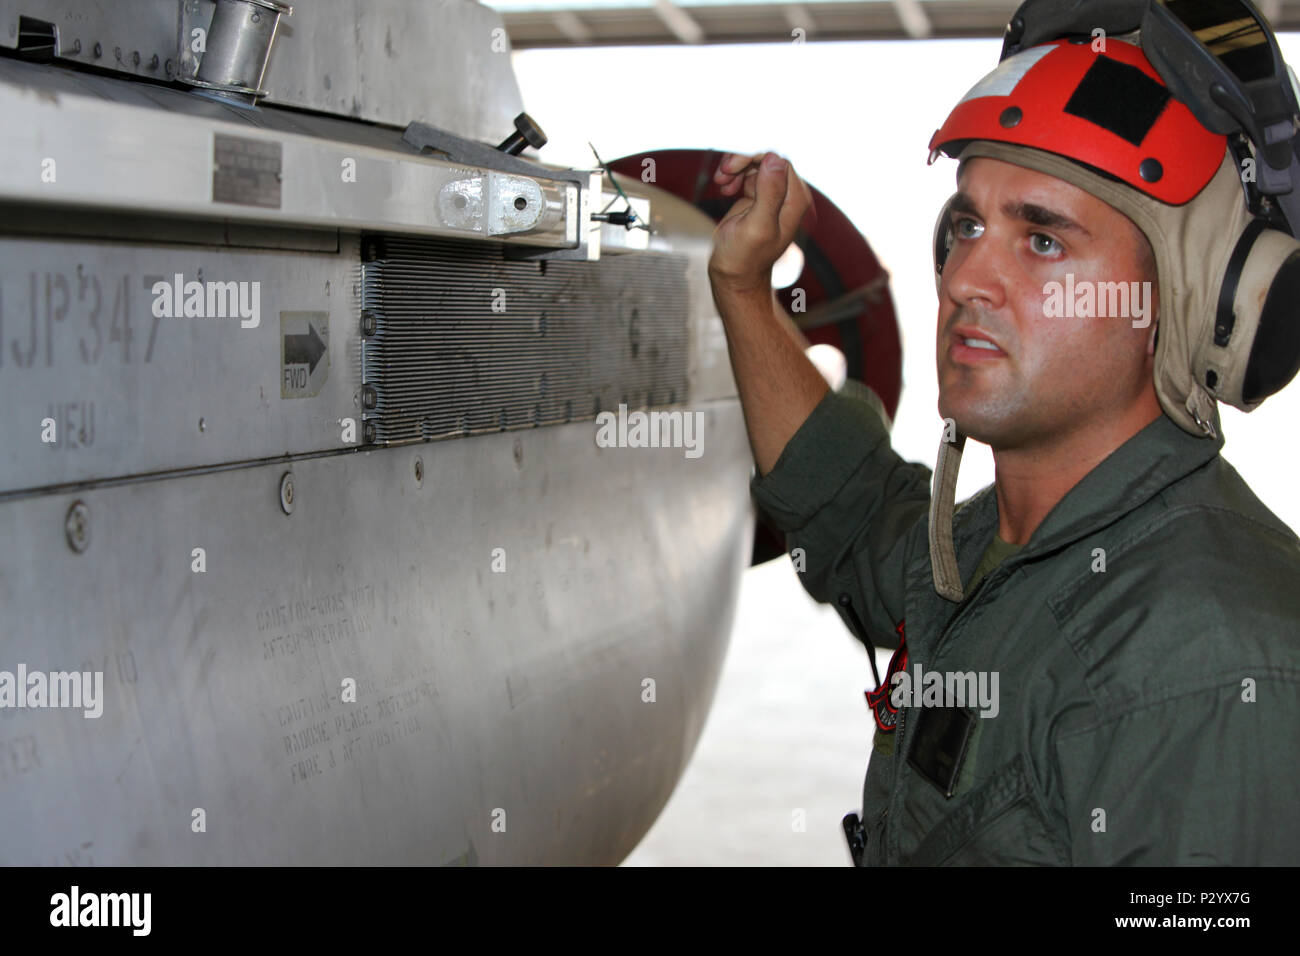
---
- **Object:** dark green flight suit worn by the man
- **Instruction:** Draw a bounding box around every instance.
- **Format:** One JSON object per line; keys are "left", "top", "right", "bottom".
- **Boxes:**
{"left": 751, "top": 384, "right": 1300, "bottom": 865}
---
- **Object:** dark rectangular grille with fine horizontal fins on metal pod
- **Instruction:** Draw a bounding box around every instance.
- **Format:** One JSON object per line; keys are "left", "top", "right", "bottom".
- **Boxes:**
{"left": 361, "top": 237, "right": 689, "bottom": 444}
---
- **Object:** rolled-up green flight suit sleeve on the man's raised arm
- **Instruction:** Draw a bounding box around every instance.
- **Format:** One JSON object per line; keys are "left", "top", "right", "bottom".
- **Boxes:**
{"left": 750, "top": 381, "right": 931, "bottom": 648}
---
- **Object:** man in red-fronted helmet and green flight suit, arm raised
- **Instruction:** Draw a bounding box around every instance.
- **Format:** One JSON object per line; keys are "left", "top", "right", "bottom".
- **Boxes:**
{"left": 710, "top": 20, "right": 1300, "bottom": 865}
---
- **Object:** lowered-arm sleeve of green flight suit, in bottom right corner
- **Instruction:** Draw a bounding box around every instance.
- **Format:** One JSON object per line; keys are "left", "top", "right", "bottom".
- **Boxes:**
{"left": 1058, "top": 674, "right": 1300, "bottom": 866}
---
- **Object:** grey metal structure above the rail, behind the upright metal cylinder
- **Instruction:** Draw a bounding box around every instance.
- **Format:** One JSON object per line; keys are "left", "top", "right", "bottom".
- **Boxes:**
{"left": 0, "top": 0, "right": 524, "bottom": 142}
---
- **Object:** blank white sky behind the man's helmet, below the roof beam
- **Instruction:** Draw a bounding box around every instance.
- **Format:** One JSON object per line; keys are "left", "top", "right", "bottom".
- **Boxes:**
{"left": 514, "top": 34, "right": 1300, "bottom": 528}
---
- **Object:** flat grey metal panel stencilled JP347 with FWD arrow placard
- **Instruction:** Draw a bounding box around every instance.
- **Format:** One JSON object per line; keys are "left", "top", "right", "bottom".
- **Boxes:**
{"left": 0, "top": 235, "right": 361, "bottom": 494}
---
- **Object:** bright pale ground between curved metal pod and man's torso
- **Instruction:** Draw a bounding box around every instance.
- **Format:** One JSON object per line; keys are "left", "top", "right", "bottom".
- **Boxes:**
{"left": 624, "top": 558, "right": 891, "bottom": 866}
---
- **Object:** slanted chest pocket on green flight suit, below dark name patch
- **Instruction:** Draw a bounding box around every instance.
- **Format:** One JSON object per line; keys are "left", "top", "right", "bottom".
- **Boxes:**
{"left": 906, "top": 754, "right": 1069, "bottom": 866}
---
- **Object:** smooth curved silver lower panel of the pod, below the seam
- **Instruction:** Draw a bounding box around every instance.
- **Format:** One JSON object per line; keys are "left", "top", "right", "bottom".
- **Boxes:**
{"left": 0, "top": 403, "right": 753, "bottom": 865}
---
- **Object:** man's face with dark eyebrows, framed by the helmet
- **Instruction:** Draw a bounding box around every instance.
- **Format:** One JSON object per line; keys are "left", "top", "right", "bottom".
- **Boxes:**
{"left": 937, "top": 156, "right": 1157, "bottom": 450}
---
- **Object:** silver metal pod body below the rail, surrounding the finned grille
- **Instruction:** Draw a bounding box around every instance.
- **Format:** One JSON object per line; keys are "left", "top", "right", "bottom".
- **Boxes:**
{"left": 0, "top": 22, "right": 753, "bottom": 865}
